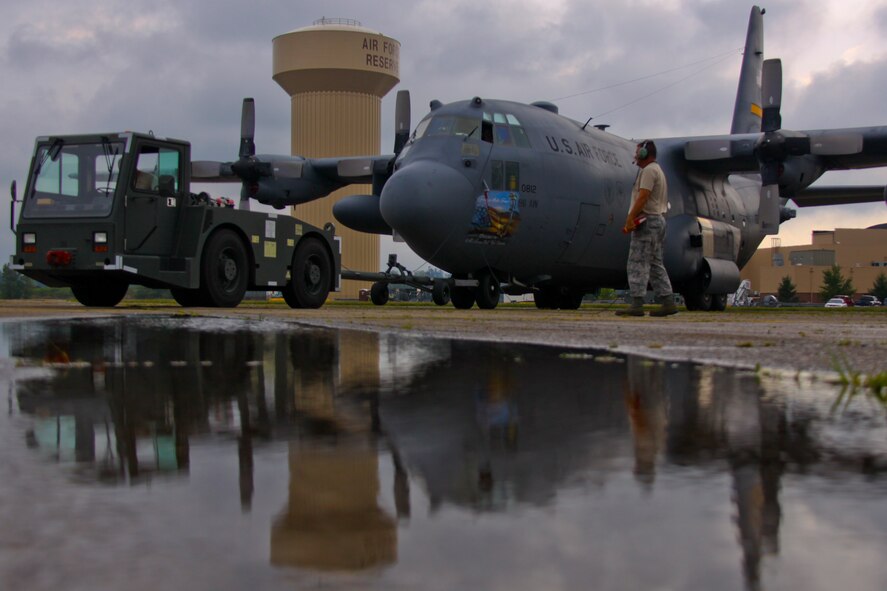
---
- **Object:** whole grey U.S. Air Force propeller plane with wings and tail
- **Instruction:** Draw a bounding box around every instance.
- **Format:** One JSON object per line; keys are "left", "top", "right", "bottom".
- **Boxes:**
{"left": 192, "top": 6, "right": 887, "bottom": 311}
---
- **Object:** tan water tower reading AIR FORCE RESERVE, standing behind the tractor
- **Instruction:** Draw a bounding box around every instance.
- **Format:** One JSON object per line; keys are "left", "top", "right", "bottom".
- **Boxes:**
{"left": 273, "top": 19, "right": 400, "bottom": 298}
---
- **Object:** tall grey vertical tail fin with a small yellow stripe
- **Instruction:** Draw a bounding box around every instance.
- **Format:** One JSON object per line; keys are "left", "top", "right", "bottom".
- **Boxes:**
{"left": 730, "top": 6, "right": 764, "bottom": 133}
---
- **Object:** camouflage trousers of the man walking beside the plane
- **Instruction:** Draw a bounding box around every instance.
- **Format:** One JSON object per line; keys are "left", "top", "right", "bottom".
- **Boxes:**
{"left": 628, "top": 215, "right": 672, "bottom": 298}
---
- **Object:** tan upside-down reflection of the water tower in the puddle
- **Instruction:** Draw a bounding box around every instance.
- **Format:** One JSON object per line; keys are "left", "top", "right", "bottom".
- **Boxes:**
{"left": 271, "top": 334, "right": 397, "bottom": 571}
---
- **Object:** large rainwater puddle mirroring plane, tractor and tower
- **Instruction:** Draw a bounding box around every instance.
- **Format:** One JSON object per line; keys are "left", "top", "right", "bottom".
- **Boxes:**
{"left": 0, "top": 317, "right": 887, "bottom": 591}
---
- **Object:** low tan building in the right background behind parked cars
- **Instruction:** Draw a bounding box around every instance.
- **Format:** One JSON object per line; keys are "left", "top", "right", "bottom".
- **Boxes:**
{"left": 741, "top": 227, "right": 887, "bottom": 302}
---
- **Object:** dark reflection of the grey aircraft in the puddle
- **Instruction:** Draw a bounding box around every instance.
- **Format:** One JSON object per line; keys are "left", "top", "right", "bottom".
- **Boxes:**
{"left": 381, "top": 343, "right": 820, "bottom": 589}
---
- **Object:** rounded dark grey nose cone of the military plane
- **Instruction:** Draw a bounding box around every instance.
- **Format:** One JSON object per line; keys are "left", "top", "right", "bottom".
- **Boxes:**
{"left": 380, "top": 160, "right": 473, "bottom": 247}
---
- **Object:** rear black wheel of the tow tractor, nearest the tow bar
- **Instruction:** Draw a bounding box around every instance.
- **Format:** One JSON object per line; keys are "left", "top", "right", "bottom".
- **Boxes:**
{"left": 280, "top": 238, "right": 333, "bottom": 308}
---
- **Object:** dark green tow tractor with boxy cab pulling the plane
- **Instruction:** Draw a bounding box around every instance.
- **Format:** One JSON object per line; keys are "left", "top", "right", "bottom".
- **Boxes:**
{"left": 10, "top": 132, "right": 341, "bottom": 308}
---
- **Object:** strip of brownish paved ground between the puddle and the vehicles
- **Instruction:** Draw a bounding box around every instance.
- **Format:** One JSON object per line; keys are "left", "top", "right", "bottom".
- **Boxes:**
{"left": 0, "top": 300, "right": 887, "bottom": 375}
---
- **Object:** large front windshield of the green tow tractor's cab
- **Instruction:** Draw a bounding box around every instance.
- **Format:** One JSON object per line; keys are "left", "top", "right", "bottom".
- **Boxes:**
{"left": 22, "top": 139, "right": 124, "bottom": 218}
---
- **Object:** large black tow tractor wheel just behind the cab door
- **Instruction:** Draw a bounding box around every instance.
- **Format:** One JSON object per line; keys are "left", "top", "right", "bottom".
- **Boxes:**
{"left": 200, "top": 228, "right": 249, "bottom": 308}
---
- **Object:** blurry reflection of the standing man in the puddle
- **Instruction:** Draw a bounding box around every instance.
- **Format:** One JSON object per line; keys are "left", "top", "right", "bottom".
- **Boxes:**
{"left": 625, "top": 358, "right": 668, "bottom": 487}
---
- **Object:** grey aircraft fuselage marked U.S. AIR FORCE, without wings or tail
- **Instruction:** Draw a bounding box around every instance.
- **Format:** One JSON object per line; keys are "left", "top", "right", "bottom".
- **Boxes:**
{"left": 381, "top": 99, "right": 764, "bottom": 298}
